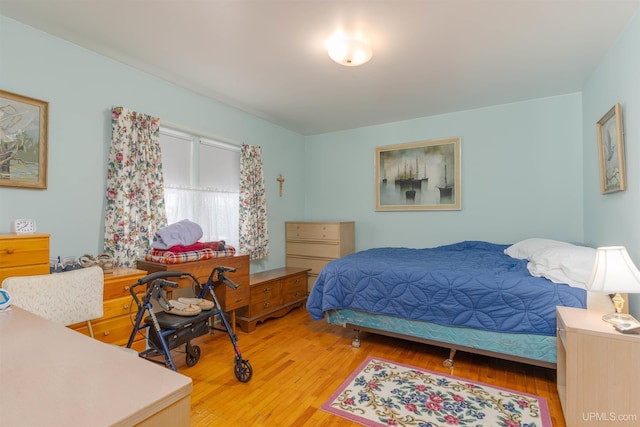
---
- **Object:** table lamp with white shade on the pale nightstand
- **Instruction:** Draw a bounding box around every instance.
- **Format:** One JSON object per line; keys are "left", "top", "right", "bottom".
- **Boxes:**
{"left": 587, "top": 246, "right": 640, "bottom": 323}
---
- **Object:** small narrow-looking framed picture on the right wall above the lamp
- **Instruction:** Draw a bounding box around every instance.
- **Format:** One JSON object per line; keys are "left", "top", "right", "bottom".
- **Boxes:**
{"left": 596, "top": 104, "right": 627, "bottom": 194}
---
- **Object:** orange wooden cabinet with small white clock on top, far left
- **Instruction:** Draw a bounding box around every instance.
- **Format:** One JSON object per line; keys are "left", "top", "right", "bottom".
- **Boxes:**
{"left": 0, "top": 234, "right": 49, "bottom": 286}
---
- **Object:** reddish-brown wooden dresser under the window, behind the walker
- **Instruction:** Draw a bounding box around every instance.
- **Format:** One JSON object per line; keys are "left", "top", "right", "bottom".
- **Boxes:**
{"left": 137, "top": 255, "right": 250, "bottom": 332}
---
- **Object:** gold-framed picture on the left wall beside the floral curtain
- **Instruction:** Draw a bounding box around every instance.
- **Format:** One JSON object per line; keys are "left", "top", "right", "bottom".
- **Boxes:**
{"left": 0, "top": 90, "right": 49, "bottom": 189}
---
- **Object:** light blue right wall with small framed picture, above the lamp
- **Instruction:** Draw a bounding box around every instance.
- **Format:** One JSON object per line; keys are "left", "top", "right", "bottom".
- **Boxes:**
{"left": 582, "top": 12, "right": 640, "bottom": 318}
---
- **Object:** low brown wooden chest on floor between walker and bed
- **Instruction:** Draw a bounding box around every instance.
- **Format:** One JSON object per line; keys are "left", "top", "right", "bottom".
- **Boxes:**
{"left": 237, "top": 267, "right": 309, "bottom": 332}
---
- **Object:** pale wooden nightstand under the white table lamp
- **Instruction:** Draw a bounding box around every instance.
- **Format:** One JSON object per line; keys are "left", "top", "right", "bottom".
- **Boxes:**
{"left": 556, "top": 307, "right": 640, "bottom": 427}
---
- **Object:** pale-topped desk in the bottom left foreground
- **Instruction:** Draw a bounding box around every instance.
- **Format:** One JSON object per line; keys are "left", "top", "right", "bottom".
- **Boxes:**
{"left": 0, "top": 306, "right": 192, "bottom": 427}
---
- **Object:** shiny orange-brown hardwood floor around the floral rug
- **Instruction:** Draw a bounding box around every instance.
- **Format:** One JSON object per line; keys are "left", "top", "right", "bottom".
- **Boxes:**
{"left": 172, "top": 308, "right": 565, "bottom": 427}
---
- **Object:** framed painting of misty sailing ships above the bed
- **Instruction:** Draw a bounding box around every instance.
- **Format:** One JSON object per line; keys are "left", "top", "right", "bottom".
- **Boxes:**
{"left": 375, "top": 137, "right": 462, "bottom": 211}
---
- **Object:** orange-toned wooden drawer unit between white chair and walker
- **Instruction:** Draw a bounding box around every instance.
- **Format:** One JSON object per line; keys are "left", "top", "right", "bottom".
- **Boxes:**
{"left": 70, "top": 267, "right": 147, "bottom": 352}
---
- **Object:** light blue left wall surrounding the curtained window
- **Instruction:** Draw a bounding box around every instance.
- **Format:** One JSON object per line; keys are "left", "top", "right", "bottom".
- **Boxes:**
{"left": 0, "top": 16, "right": 305, "bottom": 271}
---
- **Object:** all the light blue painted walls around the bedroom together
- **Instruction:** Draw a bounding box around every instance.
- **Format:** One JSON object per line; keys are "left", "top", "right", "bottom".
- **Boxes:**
{"left": 5, "top": 11, "right": 640, "bottom": 317}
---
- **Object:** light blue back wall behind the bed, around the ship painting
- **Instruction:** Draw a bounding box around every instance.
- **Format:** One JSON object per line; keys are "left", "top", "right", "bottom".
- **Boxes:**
{"left": 305, "top": 94, "right": 583, "bottom": 250}
